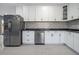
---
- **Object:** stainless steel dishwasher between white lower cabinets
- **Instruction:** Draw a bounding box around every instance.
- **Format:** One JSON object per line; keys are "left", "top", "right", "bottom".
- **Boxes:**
{"left": 35, "top": 30, "right": 45, "bottom": 45}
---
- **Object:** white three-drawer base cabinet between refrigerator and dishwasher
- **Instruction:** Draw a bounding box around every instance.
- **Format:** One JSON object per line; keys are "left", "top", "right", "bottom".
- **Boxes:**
{"left": 22, "top": 31, "right": 35, "bottom": 44}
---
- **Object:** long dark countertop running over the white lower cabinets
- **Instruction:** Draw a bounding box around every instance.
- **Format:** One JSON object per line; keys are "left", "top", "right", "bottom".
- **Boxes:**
{"left": 22, "top": 28, "right": 79, "bottom": 32}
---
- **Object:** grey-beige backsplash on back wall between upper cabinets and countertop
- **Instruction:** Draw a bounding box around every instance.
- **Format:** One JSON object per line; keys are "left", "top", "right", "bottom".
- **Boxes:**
{"left": 25, "top": 21, "right": 68, "bottom": 29}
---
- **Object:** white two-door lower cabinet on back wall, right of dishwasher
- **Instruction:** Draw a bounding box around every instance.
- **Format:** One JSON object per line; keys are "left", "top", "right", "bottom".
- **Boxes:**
{"left": 45, "top": 31, "right": 64, "bottom": 44}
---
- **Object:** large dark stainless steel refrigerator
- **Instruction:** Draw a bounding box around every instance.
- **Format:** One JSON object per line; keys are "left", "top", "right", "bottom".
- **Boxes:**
{"left": 4, "top": 15, "right": 23, "bottom": 46}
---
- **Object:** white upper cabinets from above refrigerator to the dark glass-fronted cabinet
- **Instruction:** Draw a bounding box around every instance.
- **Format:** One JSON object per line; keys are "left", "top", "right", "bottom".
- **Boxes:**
{"left": 16, "top": 5, "right": 63, "bottom": 21}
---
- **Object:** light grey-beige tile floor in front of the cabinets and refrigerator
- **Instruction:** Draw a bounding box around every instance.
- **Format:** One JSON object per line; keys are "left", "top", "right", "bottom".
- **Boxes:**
{"left": 0, "top": 44, "right": 76, "bottom": 55}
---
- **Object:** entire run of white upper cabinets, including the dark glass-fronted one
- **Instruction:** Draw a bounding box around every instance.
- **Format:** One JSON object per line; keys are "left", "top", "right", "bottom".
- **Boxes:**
{"left": 16, "top": 3, "right": 79, "bottom": 21}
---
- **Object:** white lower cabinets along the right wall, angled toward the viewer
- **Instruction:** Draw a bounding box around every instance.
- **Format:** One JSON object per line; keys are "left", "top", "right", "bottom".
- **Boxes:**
{"left": 64, "top": 31, "right": 79, "bottom": 53}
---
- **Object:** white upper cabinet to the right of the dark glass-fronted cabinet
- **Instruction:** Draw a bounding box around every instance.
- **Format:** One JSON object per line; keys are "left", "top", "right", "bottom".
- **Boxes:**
{"left": 68, "top": 3, "right": 79, "bottom": 20}
